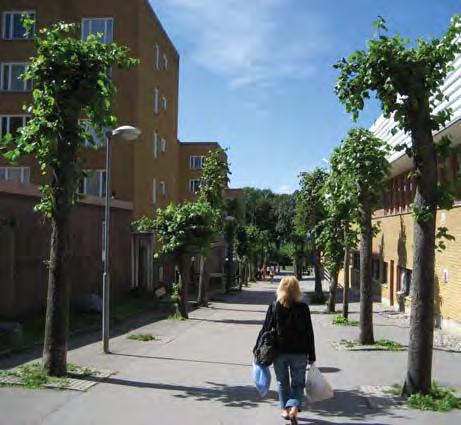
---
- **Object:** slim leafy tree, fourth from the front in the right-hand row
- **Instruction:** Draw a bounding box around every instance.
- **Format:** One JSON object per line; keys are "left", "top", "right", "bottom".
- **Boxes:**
{"left": 295, "top": 168, "right": 328, "bottom": 299}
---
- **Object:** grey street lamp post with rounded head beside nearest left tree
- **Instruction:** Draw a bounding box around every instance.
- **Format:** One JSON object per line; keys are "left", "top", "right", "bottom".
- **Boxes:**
{"left": 102, "top": 125, "right": 141, "bottom": 353}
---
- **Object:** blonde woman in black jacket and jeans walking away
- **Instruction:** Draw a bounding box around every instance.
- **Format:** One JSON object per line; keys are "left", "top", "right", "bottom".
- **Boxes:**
{"left": 256, "top": 276, "right": 315, "bottom": 424}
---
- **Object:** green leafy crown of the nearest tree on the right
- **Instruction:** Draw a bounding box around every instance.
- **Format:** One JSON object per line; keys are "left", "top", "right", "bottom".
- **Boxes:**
{"left": 335, "top": 15, "right": 461, "bottom": 222}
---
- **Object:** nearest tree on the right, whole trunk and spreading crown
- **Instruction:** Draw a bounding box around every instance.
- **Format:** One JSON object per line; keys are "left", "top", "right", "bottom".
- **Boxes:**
{"left": 336, "top": 15, "right": 461, "bottom": 394}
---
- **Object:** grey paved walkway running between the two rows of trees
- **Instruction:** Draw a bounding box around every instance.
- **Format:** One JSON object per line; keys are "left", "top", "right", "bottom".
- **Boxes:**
{"left": 0, "top": 282, "right": 461, "bottom": 425}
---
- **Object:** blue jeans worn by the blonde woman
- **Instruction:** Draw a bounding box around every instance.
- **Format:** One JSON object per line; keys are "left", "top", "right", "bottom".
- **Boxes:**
{"left": 274, "top": 354, "right": 309, "bottom": 409}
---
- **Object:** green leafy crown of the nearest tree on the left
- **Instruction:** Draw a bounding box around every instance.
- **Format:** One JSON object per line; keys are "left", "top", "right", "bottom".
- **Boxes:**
{"left": 2, "top": 20, "right": 138, "bottom": 218}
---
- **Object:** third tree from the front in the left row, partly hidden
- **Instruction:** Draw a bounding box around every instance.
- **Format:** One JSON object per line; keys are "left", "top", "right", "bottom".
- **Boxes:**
{"left": 197, "top": 149, "right": 230, "bottom": 307}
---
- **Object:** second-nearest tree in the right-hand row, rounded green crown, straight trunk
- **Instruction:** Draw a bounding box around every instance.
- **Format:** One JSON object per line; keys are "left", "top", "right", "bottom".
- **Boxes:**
{"left": 339, "top": 128, "right": 390, "bottom": 344}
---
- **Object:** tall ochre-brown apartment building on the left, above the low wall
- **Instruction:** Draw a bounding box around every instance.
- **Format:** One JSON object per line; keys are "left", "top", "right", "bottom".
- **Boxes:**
{"left": 0, "top": 0, "right": 223, "bottom": 217}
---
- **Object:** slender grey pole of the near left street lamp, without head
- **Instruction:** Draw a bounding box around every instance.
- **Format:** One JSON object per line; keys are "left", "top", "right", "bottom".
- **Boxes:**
{"left": 102, "top": 133, "right": 111, "bottom": 353}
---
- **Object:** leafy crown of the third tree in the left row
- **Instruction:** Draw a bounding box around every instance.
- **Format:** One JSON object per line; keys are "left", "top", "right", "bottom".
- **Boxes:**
{"left": 198, "top": 149, "right": 230, "bottom": 211}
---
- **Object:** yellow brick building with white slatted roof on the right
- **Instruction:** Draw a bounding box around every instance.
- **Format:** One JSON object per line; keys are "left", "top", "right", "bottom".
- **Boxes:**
{"left": 351, "top": 49, "right": 461, "bottom": 332}
